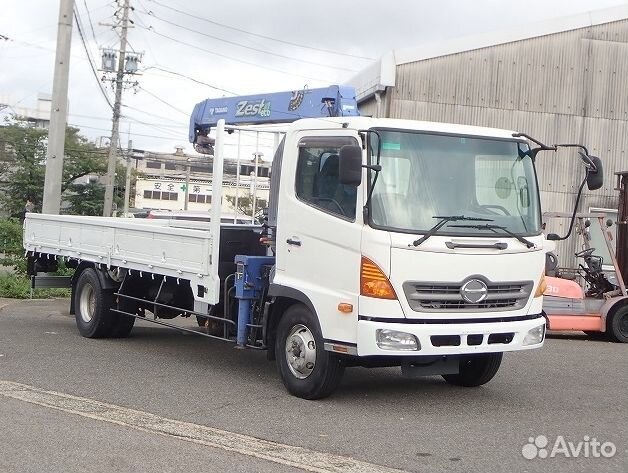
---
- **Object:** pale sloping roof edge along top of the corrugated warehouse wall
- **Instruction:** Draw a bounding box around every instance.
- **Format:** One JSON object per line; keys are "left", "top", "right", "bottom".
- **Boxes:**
{"left": 348, "top": 4, "right": 628, "bottom": 101}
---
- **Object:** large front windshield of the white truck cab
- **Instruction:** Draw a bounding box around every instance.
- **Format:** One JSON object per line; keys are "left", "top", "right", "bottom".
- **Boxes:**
{"left": 369, "top": 129, "right": 541, "bottom": 236}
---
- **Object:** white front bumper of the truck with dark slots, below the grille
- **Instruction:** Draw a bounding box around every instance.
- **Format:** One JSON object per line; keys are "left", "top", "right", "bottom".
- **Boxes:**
{"left": 357, "top": 314, "right": 545, "bottom": 356}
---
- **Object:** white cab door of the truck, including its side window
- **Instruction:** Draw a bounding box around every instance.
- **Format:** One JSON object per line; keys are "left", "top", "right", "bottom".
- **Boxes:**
{"left": 274, "top": 131, "right": 363, "bottom": 343}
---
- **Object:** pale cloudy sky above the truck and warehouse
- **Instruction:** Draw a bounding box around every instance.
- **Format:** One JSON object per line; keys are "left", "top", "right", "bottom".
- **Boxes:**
{"left": 0, "top": 0, "right": 628, "bottom": 152}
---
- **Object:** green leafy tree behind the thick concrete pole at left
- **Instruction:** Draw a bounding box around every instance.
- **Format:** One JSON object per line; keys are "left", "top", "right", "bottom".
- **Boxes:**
{"left": 0, "top": 118, "right": 107, "bottom": 215}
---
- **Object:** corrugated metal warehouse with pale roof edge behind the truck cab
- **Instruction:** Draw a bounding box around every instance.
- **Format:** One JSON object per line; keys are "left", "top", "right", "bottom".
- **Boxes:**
{"left": 351, "top": 5, "right": 628, "bottom": 266}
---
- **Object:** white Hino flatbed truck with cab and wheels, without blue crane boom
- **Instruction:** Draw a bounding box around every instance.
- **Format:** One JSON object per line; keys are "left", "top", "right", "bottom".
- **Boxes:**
{"left": 24, "top": 86, "right": 602, "bottom": 399}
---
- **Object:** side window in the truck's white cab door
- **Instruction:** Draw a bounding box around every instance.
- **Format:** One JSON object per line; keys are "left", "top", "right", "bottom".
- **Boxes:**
{"left": 296, "top": 137, "right": 357, "bottom": 220}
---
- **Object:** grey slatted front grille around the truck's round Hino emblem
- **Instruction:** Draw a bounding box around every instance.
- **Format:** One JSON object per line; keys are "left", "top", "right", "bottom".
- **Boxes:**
{"left": 403, "top": 277, "right": 533, "bottom": 312}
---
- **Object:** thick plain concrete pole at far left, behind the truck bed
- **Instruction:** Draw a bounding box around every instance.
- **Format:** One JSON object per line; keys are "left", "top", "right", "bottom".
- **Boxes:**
{"left": 42, "top": 0, "right": 74, "bottom": 214}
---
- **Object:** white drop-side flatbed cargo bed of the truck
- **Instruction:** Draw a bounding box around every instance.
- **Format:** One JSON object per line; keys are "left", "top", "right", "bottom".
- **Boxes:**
{"left": 24, "top": 213, "right": 261, "bottom": 304}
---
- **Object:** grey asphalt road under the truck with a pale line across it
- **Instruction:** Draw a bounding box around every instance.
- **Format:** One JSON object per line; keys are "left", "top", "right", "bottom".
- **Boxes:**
{"left": 0, "top": 300, "right": 628, "bottom": 473}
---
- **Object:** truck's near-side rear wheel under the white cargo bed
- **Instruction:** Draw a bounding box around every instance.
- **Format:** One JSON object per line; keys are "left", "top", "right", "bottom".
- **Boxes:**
{"left": 74, "top": 268, "right": 116, "bottom": 338}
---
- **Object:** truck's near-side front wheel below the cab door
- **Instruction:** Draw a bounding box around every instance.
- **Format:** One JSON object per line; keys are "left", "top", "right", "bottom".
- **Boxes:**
{"left": 275, "top": 304, "right": 344, "bottom": 399}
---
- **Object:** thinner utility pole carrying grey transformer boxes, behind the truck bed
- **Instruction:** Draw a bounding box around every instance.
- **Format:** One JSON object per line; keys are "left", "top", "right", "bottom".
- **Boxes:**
{"left": 103, "top": 0, "right": 130, "bottom": 217}
